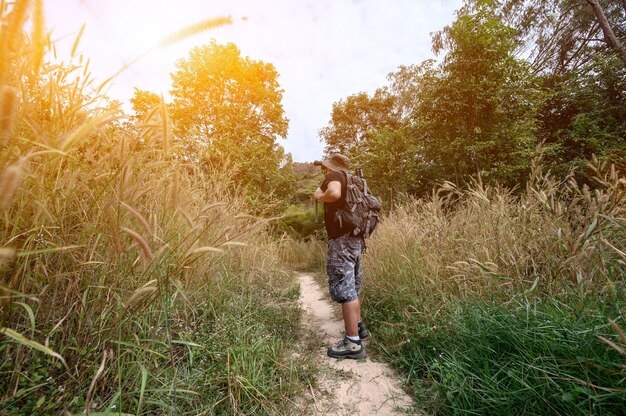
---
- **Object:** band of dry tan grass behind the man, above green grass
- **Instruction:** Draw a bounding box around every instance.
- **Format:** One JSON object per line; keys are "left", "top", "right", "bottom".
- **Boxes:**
{"left": 366, "top": 154, "right": 626, "bottom": 308}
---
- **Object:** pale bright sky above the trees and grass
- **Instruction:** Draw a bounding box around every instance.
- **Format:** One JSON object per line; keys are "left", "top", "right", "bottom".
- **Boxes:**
{"left": 45, "top": 0, "right": 462, "bottom": 162}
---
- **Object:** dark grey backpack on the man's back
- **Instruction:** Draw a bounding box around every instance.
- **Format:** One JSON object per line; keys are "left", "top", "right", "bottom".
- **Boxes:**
{"left": 336, "top": 172, "right": 382, "bottom": 238}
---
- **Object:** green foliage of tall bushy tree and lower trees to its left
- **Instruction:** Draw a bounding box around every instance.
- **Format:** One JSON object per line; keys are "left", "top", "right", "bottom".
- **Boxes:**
{"left": 320, "top": 2, "right": 541, "bottom": 201}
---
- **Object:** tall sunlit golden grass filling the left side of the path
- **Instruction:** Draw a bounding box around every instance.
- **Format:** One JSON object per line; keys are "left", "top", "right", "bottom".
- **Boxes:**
{"left": 0, "top": 1, "right": 309, "bottom": 415}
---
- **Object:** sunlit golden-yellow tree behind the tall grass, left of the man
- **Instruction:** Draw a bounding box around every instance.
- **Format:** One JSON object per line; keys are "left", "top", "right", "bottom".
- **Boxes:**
{"left": 171, "top": 41, "right": 291, "bottom": 211}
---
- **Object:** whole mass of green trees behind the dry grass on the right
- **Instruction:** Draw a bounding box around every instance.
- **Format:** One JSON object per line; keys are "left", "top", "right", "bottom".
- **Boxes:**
{"left": 320, "top": 0, "right": 626, "bottom": 202}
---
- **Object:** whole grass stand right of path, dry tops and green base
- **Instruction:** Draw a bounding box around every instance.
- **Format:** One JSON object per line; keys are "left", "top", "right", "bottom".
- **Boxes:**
{"left": 363, "top": 157, "right": 626, "bottom": 415}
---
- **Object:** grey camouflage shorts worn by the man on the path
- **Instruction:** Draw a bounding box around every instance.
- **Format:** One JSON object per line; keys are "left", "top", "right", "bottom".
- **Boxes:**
{"left": 326, "top": 235, "right": 363, "bottom": 303}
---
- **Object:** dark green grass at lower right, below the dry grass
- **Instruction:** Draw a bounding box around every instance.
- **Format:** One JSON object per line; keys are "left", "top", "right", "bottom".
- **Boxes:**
{"left": 367, "top": 299, "right": 626, "bottom": 415}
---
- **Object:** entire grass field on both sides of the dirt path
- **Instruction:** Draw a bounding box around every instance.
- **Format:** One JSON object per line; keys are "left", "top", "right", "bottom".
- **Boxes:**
{"left": 0, "top": 1, "right": 626, "bottom": 415}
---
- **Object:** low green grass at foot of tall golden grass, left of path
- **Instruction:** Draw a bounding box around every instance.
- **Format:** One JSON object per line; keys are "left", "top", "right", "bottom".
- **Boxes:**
{"left": 0, "top": 273, "right": 314, "bottom": 415}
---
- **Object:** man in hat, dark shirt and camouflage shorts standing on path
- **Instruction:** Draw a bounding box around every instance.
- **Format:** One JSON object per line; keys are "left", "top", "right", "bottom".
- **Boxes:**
{"left": 313, "top": 153, "right": 369, "bottom": 359}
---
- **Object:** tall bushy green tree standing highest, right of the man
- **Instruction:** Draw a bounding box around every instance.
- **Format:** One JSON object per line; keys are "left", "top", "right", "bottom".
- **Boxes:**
{"left": 424, "top": 1, "right": 541, "bottom": 185}
